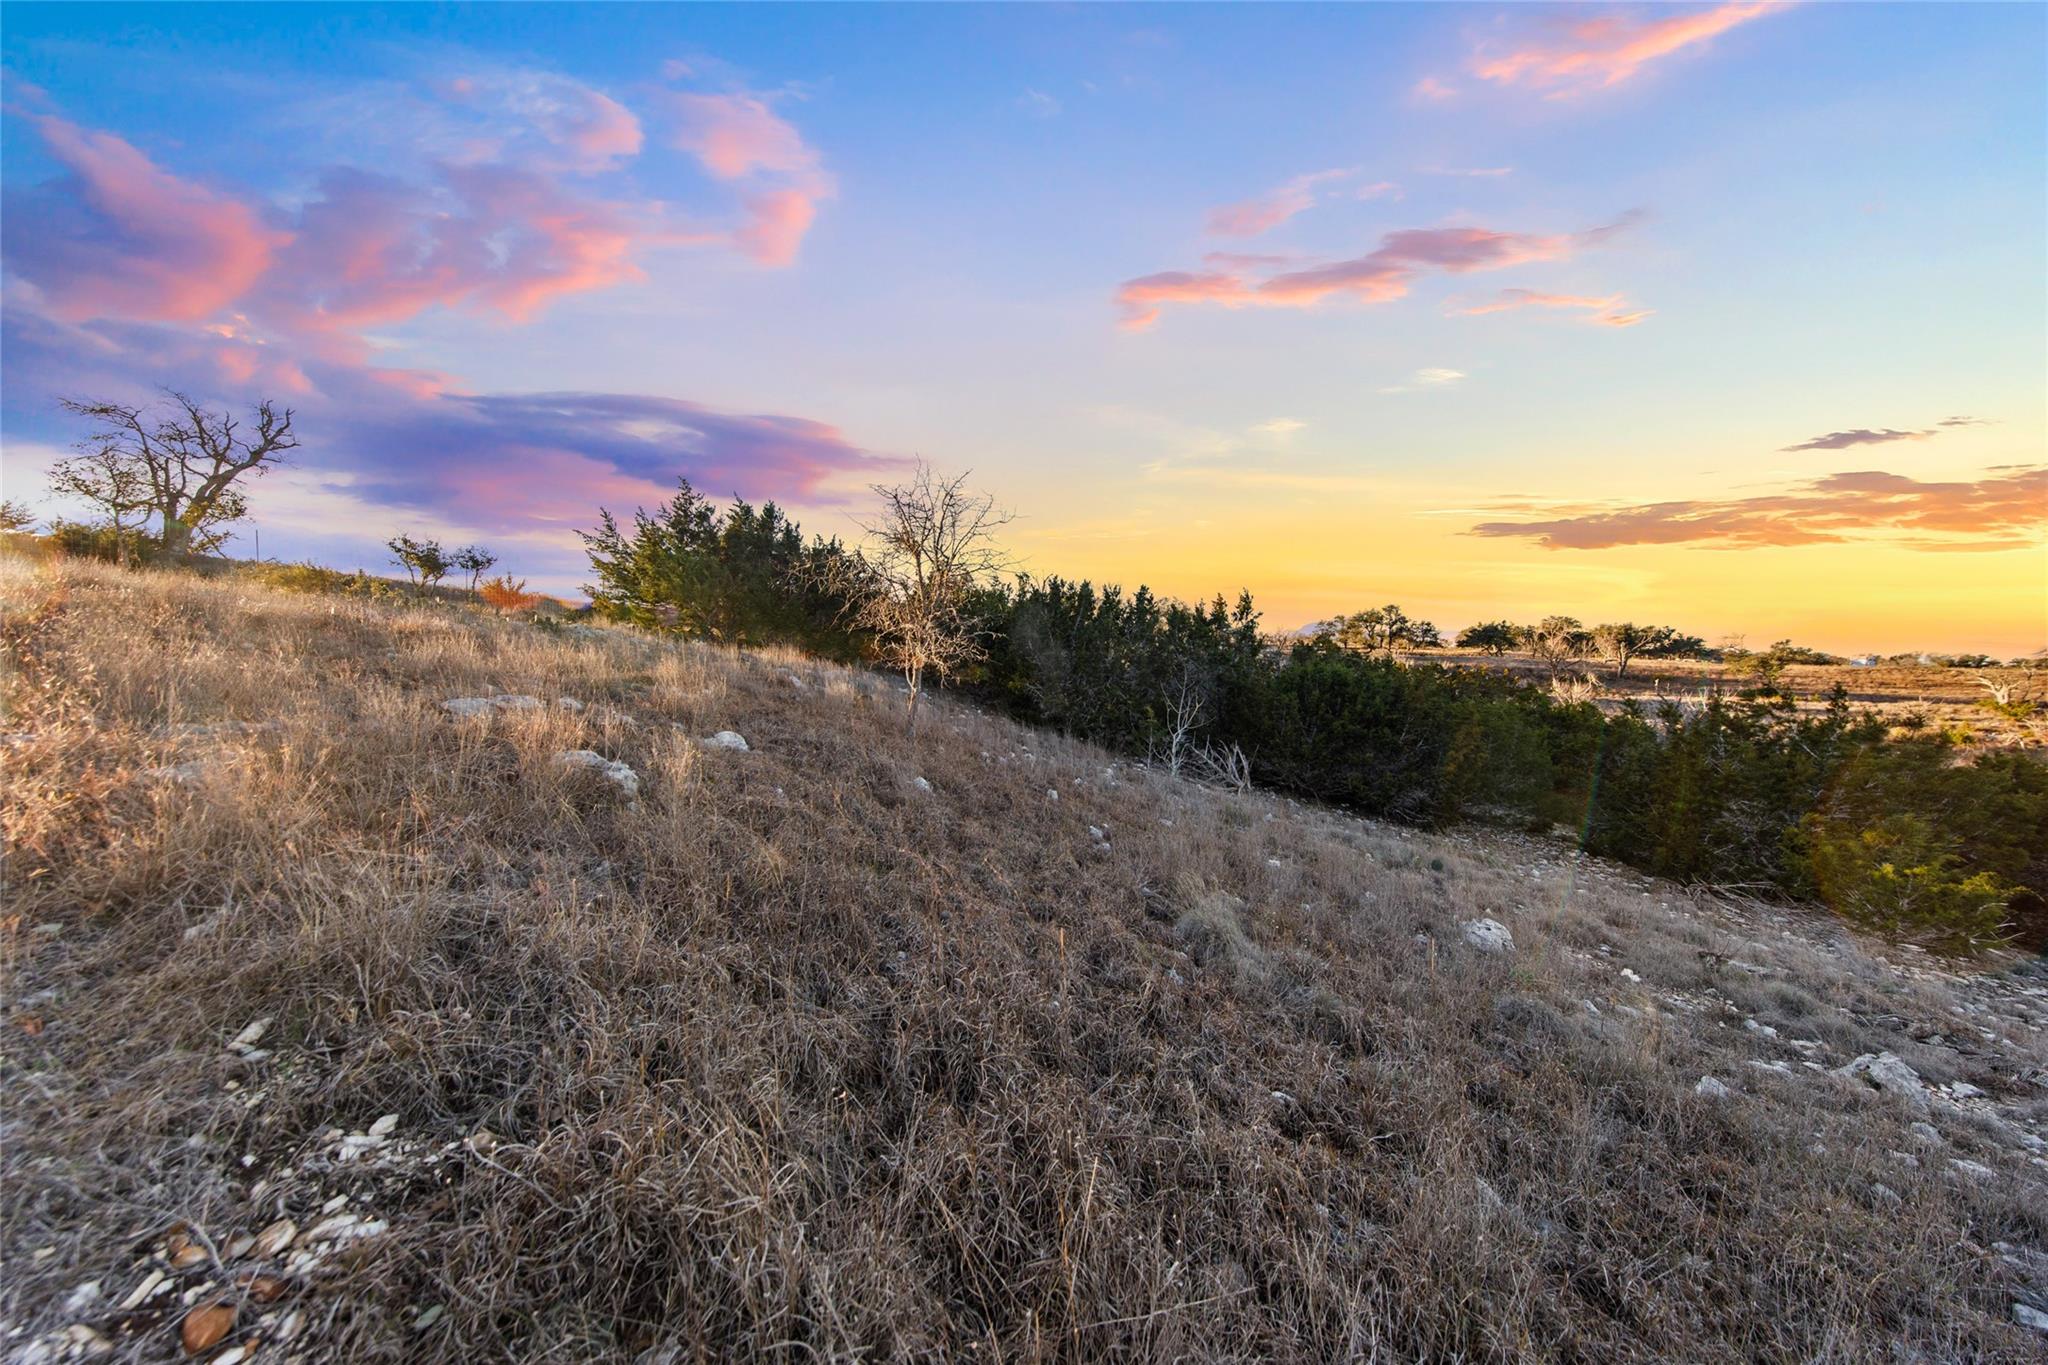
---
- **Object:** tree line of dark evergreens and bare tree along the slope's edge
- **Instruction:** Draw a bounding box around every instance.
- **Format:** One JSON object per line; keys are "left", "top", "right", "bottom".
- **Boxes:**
{"left": 586, "top": 471, "right": 2048, "bottom": 950}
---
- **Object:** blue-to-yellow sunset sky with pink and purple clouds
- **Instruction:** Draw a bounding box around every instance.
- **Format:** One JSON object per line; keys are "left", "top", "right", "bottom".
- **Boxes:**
{"left": 0, "top": 2, "right": 2048, "bottom": 657}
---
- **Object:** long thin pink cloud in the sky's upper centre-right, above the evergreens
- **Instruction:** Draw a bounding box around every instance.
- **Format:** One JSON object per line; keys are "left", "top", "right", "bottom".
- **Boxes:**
{"left": 1116, "top": 213, "right": 1636, "bottom": 332}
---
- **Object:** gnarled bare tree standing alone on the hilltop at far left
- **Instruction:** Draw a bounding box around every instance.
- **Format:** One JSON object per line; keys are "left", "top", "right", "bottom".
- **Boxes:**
{"left": 61, "top": 391, "right": 299, "bottom": 557}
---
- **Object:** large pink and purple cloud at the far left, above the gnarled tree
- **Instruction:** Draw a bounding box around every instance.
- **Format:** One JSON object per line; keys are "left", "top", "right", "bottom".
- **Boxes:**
{"left": 6, "top": 115, "right": 289, "bottom": 321}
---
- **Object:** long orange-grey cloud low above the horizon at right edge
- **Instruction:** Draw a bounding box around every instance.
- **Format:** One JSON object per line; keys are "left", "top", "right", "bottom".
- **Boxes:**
{"left": 1470, "top": 467, "right": 2048, "bottom": 551}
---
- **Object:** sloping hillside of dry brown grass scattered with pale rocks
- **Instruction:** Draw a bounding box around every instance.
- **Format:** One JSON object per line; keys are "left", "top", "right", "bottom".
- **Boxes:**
{"left": 0, "top": 559, "right": 2048, "bottom": 1365}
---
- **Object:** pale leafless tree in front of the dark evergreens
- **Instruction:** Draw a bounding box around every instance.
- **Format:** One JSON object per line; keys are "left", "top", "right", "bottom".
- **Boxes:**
{"left": 831, "top": 460, "right": 1012, "bottom": 729}
